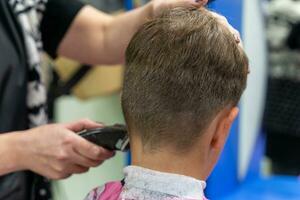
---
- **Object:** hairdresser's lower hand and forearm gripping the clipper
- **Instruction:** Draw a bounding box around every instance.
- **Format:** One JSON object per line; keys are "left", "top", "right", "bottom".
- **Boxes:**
{"left": 0, "top": 120, "right": 114, "bottom": 179}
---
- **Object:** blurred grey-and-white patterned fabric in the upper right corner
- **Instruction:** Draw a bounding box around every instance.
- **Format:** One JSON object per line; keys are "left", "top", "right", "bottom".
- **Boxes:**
{"left": 266, "top": 0, "right": 300, "bottom": 81}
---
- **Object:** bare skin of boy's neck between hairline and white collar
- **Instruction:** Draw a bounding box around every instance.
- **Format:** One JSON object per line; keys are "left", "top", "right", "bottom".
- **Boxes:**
{"left": 131, "top": 138, "right": 207, "bottom": 180}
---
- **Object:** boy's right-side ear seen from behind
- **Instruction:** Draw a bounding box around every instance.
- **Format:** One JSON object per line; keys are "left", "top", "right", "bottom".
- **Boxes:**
{"left": 211, "top": 107, "right": 239, "bottom": 151}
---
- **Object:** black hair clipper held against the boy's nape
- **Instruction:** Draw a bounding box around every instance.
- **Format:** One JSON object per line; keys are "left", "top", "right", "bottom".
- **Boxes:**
{"left": 78, "top": 124, "right": 130, "bottom": 152}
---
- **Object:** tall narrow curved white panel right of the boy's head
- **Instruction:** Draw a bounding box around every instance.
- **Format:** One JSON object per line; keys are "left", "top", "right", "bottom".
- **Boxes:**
{"left": 239, "top": 0, "right": 267, "bottom": 177}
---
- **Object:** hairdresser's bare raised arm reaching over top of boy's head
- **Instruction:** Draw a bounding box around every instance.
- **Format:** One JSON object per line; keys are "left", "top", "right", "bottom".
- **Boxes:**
{"left": 58, "top": 0, "right": 207, "bottom": 64}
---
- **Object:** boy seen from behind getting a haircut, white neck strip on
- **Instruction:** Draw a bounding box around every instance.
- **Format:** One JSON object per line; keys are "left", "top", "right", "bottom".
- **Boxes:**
{"left": 87, "top": 8, "right": 248, "bottom": 200}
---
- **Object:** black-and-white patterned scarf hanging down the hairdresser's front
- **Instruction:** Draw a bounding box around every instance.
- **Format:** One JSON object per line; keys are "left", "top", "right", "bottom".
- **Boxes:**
{"left": 9, "top": 0, "right": 52, "bottom": 200}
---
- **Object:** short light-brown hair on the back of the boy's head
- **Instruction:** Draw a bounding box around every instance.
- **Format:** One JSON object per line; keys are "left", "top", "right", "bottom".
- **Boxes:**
{"left": 122, "top": 8, "right": 248, "bottom": 152}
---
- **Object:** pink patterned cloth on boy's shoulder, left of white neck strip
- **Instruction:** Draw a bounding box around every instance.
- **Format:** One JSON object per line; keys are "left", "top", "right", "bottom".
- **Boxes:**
{"left": 85, "top": 181, "right": 123, "bottom": 200}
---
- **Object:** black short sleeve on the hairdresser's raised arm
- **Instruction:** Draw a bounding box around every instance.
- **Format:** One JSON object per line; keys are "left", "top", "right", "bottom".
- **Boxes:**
{"left": 40, "top": 0, "right": 84, "bottom": 58}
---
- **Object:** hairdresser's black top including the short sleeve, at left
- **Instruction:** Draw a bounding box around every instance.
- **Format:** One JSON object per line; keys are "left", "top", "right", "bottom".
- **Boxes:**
{"left": 0, "top": 0, "right": 84, "bottom": 200}
